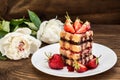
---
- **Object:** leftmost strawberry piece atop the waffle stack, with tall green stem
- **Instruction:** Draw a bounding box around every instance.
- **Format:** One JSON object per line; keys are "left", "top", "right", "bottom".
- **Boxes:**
{"left": 64, "top": 13, "right": 75, "bottom": 33}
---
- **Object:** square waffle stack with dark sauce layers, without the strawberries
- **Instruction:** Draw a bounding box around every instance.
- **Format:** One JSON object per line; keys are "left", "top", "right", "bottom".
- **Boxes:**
{"left": 60, "top": 30, "right": 93, "bottom": 65}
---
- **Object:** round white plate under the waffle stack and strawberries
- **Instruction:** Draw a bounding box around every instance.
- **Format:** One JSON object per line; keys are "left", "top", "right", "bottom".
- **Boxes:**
{"left": 31, "top": 43, "right": 117, "bottom": 77}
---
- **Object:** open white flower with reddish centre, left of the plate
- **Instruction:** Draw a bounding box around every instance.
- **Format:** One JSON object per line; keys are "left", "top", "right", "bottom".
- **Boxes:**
{"left": 0, "top": 28, "right": 41, "bottom": 60}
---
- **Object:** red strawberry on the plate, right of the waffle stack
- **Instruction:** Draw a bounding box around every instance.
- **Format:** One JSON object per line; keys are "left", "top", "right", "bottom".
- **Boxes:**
{"left": 86, "top": 56, "right": 99, "bottom": 69}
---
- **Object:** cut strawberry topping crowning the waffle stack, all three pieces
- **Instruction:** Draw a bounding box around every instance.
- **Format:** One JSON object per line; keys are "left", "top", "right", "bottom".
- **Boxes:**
{"left": 64, "top": 13, "right": 91, "bottom": 34}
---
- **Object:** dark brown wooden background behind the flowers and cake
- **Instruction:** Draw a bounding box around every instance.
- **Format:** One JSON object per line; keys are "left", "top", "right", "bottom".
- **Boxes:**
{"left": 0, "top": 0, "right": 120, "bottom": 24}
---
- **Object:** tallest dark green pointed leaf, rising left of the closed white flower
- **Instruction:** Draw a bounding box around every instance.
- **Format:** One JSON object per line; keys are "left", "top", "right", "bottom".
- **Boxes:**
{"left": 28, "top": 10, "right": 41, "bottom": 29}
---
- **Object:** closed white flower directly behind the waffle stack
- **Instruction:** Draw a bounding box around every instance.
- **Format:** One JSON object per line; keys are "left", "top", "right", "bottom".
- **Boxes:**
{"left": 37, "top": 19, "right": 63, "bottom": 44}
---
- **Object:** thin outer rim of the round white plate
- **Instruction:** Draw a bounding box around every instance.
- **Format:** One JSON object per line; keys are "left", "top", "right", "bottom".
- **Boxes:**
{"left": 31, "top": 43, "right": 117, "bottom": 78}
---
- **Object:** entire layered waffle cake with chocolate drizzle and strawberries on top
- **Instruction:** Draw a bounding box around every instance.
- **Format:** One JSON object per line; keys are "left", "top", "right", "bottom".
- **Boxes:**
{"left": 60, "top": 16, "right": 94, "bottom": 66}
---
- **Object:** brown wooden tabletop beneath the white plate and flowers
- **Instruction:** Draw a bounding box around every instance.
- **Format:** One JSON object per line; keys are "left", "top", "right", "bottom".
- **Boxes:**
{"left": 0, "top": 25, "right": 120, "bottom": 80}
